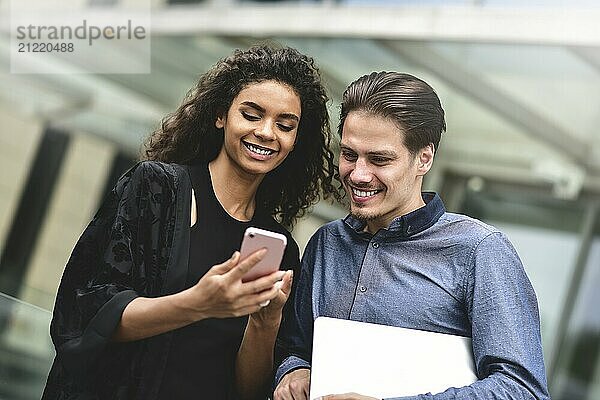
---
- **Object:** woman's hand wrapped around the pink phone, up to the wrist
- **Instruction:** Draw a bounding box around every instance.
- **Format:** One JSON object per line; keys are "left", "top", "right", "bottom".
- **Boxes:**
{"left": 181, "top": 249, "right": 291, "bottom": 320}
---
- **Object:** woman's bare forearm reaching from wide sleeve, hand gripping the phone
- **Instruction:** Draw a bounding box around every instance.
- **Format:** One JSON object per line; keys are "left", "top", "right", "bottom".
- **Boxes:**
{"left": 113, "top": 250, "right": 287, "bottom": 342}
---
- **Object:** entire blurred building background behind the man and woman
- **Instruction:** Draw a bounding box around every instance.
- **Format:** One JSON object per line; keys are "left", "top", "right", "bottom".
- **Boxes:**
{"left": 0, "top": 0, "right": 600, "bottom": 400}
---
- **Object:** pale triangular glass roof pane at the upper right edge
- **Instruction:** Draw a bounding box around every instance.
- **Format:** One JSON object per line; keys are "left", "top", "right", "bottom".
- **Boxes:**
{"left": 430, "top": 43, "right": 600, "bottom": 140}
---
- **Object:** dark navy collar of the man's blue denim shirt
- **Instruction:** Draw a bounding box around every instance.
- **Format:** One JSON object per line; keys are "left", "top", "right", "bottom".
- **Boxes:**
{"left": 344, "top": 192, "right": 446, "bottom": 237}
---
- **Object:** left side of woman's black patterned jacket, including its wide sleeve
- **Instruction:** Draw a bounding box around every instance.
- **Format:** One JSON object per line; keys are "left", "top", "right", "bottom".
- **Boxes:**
{"left": 42, "top": 161, "right": 191, "bottom": 400}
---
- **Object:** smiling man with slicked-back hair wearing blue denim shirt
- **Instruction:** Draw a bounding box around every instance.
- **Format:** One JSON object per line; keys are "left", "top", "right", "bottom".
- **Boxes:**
{"left": 274, "top": 72, "right": 549, "bottom": 400}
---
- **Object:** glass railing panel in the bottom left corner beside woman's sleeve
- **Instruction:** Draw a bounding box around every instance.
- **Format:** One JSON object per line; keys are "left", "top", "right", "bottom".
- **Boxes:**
{"left": 0, "top": 293, "right": 54, "bottom": 400}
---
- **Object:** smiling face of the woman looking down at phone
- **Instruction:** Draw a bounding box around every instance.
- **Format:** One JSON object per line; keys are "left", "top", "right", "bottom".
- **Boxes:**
{"left": 215, "top": 80, "right": 302, "bottom": 175}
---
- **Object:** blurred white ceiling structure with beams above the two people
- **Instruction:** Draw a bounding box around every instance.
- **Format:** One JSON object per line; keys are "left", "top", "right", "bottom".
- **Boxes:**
{"left": 0, "top": 0, "right": 600, "bottom": 203}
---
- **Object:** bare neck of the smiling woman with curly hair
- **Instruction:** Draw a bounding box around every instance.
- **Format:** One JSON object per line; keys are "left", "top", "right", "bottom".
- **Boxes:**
{"left": 208, "top": 154, "right": 263, "bottom": 221}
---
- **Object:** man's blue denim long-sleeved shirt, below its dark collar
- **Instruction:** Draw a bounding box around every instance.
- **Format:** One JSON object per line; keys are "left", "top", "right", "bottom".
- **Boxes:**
{"left": 275, "top": 193, "right": 549, "bottom": 400}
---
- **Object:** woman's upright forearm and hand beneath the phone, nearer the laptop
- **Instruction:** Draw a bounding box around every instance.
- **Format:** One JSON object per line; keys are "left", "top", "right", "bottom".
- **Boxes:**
{"left": 236, "top": 270, "right": 292, "bottom": 399}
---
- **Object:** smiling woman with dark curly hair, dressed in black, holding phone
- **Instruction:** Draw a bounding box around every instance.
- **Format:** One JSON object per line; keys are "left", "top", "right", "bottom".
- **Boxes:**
{"left": 43, "top": 46, "right": 337, "bottom": 400}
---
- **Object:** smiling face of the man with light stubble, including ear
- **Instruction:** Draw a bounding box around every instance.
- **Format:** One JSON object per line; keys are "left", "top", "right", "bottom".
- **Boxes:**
{"left": 339, "top": 111, "right": 433, "bottom": 233}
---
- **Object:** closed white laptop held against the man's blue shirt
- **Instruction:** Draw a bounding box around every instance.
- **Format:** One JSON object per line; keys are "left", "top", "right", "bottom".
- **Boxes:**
{"left": 310, "top": 317, "right": 477, "bottom": 399}
